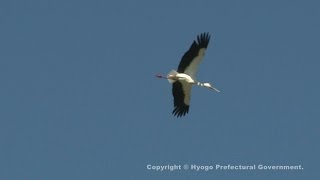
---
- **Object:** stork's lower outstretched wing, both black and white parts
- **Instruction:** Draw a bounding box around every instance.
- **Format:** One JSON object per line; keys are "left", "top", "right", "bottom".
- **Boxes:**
{"left": 172, "top": 81, "right": 192, "bottom": 117}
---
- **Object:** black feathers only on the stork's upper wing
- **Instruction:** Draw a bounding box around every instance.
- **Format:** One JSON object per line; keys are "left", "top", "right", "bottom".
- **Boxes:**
{"left": 178, "top": 33, "right": 210, "bottom": 73}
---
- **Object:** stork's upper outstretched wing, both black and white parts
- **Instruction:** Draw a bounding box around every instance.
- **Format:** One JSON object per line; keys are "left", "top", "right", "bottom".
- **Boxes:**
{"left": 178, "top": 33, "right": 210, "bottom": 78}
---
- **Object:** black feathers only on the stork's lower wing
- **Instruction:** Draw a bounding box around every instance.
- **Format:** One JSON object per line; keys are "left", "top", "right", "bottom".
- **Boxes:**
{"left": 172, "top": 81, "right": 189, "bottom": 117}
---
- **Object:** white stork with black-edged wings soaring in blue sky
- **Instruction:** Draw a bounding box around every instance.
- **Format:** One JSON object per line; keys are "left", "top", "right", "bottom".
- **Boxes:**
{"left": 156, "top": 33, "right": 220, "bottom": 117}
